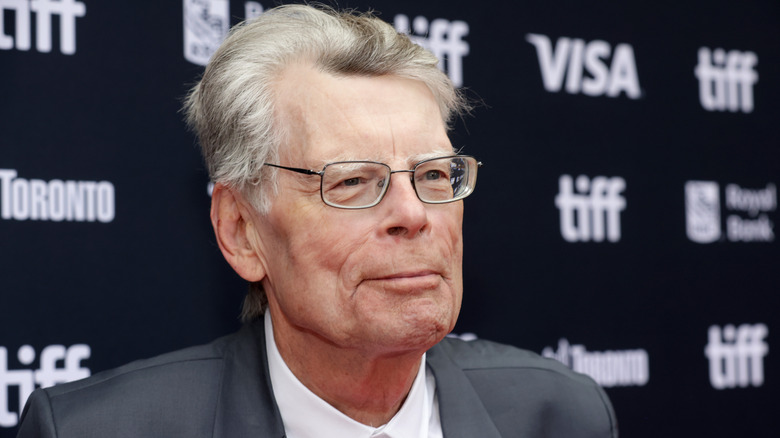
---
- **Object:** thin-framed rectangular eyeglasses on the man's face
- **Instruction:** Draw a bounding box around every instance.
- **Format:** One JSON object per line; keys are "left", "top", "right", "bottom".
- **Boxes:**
{"left": 265, "top": 155, "right": 482, "bottom": 209}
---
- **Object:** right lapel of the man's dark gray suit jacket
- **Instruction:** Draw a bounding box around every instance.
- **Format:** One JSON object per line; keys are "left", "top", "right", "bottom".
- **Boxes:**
{"left": 426, "top": 340, "right": 501, "bottom": 438}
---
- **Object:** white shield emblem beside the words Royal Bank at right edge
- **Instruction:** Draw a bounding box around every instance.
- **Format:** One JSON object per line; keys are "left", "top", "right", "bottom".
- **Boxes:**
{"left": 685, "top": 181, "right": 721, "bottom": 243}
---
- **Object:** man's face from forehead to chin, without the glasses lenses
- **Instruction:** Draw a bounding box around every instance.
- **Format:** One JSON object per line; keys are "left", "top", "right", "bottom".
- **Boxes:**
{"left": 253, "top": 66, "right": 463, "bottom": 354}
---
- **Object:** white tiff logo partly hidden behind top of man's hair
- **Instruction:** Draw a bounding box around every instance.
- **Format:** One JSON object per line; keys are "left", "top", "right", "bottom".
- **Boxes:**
{"left": 393, "top": 14, "right": 469, "bottom": 87}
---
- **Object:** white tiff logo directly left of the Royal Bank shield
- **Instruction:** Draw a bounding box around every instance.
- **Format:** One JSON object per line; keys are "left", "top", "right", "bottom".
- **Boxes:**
{"left": 555, "top": 175, "right": 626, "bottom": 242}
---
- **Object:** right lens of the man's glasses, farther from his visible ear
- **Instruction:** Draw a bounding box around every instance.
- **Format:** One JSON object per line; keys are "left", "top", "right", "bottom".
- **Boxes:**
{"left": 414, "top": 157, "right": 477, "bottom": 204}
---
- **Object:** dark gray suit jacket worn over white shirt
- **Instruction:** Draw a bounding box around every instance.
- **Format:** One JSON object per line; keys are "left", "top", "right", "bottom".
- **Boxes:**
{"left": 18, "top": 320, "right": 617, "bottom": 438}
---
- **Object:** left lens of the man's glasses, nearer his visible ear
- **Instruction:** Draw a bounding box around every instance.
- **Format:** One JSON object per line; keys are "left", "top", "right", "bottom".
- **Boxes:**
{"left": 322, "top": 161, "right": 390, "bottom": 208}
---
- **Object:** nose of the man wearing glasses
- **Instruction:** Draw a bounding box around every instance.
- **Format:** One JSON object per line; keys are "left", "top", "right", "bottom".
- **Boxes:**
{"left": 379, "top": 172, "right": 429, "bottom": 238}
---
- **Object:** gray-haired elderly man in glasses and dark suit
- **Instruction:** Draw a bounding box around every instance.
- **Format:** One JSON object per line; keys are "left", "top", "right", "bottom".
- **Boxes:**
{"left": 19, "top": 6, "right": 617, "bottom": 438}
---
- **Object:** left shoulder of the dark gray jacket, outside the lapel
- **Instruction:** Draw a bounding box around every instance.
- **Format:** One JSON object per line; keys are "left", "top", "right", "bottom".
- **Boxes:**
{"left": 19, "top": 335, "right": 242, "bottom": 437}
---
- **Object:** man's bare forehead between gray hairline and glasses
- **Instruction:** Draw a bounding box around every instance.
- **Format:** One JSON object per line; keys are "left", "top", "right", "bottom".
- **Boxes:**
{"left": 276, "top": 65, "right": 452, "bottom": 166}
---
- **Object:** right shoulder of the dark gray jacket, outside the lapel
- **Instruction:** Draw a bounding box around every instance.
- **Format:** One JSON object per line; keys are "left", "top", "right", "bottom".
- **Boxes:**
{"left": 429, "top": 338, "right": 617, "bottom": 438}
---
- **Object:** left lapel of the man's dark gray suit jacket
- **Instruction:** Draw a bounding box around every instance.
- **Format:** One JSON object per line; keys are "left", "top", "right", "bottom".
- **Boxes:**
{"left": 213, "top": 319, "right": 284, "bottom": 438}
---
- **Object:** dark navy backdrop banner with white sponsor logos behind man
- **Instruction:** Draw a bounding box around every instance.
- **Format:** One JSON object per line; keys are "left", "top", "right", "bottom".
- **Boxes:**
{"left": 0, "top": 0, "right": 780, "bottom": 437}
